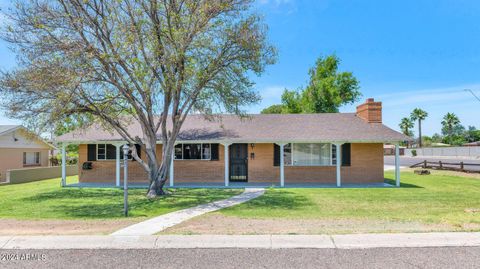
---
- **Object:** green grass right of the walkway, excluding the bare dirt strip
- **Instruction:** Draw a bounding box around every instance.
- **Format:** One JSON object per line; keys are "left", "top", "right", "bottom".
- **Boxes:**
{"left": 220, "top": 171, "right": 480, "bottom": 227}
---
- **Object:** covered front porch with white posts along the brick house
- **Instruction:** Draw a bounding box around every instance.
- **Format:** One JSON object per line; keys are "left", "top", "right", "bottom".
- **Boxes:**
{"left": 62, "top": 141, "right": 400, "bottom": 189}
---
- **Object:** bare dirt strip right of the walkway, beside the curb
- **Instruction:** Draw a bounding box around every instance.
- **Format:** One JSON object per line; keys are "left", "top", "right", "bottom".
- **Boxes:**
{"left": 162, "top": 213, "right": 480, "bottom": 234}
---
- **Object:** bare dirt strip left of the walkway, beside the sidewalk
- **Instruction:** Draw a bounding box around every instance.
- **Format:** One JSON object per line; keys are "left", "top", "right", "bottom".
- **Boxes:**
{"left": 0, "top": 219, "right": 141, "bottom": 235}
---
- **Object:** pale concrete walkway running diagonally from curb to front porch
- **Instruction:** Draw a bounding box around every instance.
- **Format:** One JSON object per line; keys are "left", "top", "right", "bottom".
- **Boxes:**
{"left": 112, "top": 188, "right": 265, "bottom": 236}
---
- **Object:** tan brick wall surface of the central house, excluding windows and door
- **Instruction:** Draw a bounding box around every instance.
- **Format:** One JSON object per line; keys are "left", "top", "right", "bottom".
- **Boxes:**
{"left": 79, "top": 143, "right": 384, "bottom": 184}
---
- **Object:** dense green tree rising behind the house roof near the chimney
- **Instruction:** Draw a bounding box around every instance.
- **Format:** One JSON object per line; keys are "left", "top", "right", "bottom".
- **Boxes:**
{"left": 262, "top": 55, "right": 361, "bottom": 113}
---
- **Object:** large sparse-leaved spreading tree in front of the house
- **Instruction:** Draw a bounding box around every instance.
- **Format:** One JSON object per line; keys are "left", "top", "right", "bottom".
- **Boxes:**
{"left": 0, "top": 0, "right": 275, "bottom": 197}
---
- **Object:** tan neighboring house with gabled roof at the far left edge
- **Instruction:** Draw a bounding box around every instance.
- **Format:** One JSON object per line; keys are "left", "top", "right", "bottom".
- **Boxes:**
{"left": 0, "top": 125, "right": 53, "bottom": 181}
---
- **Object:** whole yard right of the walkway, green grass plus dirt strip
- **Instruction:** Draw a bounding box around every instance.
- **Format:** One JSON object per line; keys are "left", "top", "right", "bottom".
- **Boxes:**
{"left": 167, "top": 171, "right": 480, "bottom": 234}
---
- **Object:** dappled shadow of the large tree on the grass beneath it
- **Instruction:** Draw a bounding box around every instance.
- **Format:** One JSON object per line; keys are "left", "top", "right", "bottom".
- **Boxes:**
{"left": 22, "top": 186, "right": 239, "bottom": 219}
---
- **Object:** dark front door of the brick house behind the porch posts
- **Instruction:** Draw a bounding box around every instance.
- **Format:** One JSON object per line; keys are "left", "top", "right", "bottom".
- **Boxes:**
{"left": 230, "top": 144, "right": 248, "bottom": 182}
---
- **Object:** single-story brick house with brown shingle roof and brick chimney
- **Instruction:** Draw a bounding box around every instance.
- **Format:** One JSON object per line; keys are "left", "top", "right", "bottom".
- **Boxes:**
{"left": 58, "top": 99, "right": 410, "bottom": 186}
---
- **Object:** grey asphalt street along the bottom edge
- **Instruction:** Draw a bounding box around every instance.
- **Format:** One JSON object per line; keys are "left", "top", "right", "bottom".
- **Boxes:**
{"left": 0, "top": 247, "right": 480, "bottom": 269}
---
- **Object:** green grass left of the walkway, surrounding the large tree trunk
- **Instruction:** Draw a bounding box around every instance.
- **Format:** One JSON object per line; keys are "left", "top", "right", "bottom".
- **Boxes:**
{"left": 0, "top": 177, "right": 242, "bottom": 219}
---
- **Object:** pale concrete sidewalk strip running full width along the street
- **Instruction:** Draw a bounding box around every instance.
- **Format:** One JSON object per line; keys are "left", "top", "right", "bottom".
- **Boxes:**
{"left": 0, "top": 232, "right": 480, "bottom": 250}
